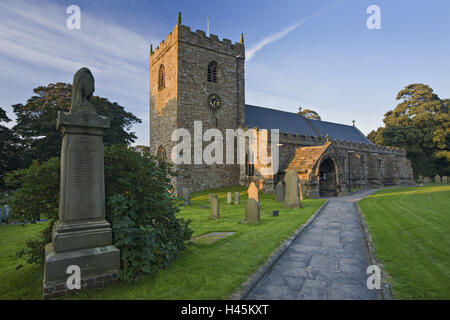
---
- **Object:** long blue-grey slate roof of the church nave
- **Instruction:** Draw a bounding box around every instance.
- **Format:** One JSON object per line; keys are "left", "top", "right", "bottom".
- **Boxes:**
{"left": 245, "top": 104, "right": 372, "bottom": 144}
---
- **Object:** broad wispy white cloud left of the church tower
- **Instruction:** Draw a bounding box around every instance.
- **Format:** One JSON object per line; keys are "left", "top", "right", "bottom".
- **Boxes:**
{"left": 0, "top": 0, "right": 158, "bottom": 142}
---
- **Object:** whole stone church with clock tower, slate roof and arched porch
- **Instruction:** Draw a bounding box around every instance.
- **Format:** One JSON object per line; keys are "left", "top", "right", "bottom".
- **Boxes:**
{"left": 149, "top": 14, "right": 413, "bottom": 198}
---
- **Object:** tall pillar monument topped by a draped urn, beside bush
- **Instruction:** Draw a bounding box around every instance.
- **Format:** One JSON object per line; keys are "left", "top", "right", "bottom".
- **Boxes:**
{"left": 43, "top": 68, "right": 120, "bottom": 299}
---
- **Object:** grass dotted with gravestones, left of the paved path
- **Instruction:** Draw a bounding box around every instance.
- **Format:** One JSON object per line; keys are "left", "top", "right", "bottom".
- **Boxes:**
{"left": 0, "top": 186, "right": 325, "bottom": 299}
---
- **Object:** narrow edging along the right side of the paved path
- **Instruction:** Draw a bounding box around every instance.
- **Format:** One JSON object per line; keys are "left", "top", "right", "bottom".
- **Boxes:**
{"left": 355, "top": 199, "right": 394, "bottom": 300}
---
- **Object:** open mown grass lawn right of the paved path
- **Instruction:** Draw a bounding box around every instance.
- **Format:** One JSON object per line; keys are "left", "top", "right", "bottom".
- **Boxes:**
{"left": 359, "top": 185, "right": 450, "bottom": 299}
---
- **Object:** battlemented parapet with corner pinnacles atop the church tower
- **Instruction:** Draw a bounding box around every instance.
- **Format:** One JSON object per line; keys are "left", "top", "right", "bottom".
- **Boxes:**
{"left": 150, "top": 12, "right": 245, "bottom": 62}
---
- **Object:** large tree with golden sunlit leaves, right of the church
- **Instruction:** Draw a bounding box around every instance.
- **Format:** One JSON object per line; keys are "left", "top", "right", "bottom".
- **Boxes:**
{"left": 372, "top": 83, "right": 450, "bottom": 176}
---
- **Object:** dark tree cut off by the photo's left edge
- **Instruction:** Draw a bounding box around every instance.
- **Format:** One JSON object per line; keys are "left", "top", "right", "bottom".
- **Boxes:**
{"left": 0, "top": 108, "right": 22, "bottom": 189}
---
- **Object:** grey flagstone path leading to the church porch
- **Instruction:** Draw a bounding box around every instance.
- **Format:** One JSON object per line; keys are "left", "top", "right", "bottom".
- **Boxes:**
{"left": 247, "top": 190, "right": 377, "bottom": 300}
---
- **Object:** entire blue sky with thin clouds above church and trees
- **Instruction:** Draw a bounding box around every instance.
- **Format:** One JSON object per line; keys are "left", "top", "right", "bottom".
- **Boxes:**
{"left": 0, "top": 0, "right": 450, "bottom": 145}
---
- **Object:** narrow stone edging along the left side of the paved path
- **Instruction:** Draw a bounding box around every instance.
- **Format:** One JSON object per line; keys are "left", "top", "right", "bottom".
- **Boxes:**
{"left": 229, "top": 200, "right": 328, "bottom": 300}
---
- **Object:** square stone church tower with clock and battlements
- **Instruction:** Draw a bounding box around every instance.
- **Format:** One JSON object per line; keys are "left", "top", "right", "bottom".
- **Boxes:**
{"left": 149, "top": 14, "right": 245, "bottom": 191}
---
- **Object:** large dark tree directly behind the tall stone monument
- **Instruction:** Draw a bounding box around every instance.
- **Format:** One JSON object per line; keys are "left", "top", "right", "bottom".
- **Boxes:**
{"left": 12, "top": 82, "right": 142, "bottom": 165}
